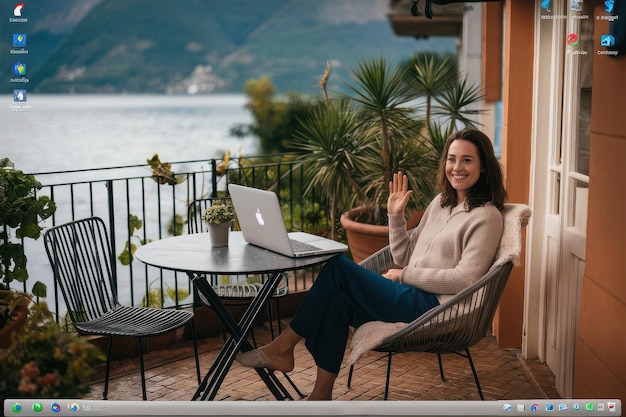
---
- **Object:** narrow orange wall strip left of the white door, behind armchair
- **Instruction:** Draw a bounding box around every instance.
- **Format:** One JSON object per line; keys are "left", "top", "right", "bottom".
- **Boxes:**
{"left": 494, "top": 0, "right": 535, "bottom": 347}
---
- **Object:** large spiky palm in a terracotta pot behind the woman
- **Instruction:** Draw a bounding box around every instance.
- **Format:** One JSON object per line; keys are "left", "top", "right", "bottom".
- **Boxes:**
{"left": 295, "top": 55, "right": 482, "bottom": 261}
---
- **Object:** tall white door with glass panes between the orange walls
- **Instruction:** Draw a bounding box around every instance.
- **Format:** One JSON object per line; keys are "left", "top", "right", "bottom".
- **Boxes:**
{"left": 524, "top": 1, "right": 597, "bottom": 398}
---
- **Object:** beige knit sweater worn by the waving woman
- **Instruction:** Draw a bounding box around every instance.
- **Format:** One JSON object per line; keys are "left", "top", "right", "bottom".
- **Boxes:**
{"left": 389, "top": 195, "right": 503, "bottom": 303}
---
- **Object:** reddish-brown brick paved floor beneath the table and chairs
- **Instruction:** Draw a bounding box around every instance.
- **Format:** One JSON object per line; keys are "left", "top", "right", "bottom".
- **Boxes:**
{"left": 81, "top": 318, "right": 559, "bottom": 401}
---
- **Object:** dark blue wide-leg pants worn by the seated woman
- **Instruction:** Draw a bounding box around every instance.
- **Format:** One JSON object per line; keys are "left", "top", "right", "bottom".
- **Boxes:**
{"left": 289, "top": 256, "right": 439, "bottom": 374}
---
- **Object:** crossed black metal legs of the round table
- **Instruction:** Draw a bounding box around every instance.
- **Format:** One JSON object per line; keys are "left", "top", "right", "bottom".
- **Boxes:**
{"left": 188, "top": 273, "right": 293, "bottom": 401}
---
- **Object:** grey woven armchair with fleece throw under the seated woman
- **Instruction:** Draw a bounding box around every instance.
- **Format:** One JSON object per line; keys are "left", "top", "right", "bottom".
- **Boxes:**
{"left": 348, "top": 204, "right": 530, "bottom": 400}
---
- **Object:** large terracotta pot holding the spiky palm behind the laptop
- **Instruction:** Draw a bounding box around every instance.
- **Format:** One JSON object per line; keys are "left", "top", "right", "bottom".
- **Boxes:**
{"left": 340, "top": 207, "right": 424, "bottom": 262}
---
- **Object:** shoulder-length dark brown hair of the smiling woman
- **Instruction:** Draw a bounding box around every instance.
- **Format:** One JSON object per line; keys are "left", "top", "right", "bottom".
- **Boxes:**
{"left": 437, "top": 129, "right": 507, "bottom": 210}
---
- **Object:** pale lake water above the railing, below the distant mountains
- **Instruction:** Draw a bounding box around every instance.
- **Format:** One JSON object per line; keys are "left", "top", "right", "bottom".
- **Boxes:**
{"left": 0, "top": 94, "right": 259, "bottom": 173}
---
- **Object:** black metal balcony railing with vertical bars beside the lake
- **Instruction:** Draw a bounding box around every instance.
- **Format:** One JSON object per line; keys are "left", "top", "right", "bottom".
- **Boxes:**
{"left": 12, "top": 154, "right": 328, "bottom": 320}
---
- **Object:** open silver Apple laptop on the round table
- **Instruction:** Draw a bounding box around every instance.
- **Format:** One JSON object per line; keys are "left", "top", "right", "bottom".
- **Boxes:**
{"left": 228, "top": 184, "right": 348, "bottom": 257}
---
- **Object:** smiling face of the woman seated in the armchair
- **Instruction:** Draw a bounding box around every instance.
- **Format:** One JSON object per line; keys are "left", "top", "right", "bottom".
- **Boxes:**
{"left": 446, "top": 139, "right": 482, "bottom": 203}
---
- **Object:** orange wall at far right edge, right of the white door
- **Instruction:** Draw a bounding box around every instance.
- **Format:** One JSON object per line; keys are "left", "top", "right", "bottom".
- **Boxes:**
{"left": 574, "top": 4, "right": 626, "bottom": 402}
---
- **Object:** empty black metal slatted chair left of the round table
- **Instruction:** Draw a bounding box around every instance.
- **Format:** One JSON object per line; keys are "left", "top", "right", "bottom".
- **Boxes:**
{"left": 44, "top": 217, "right": 200, "bottom": 400}
